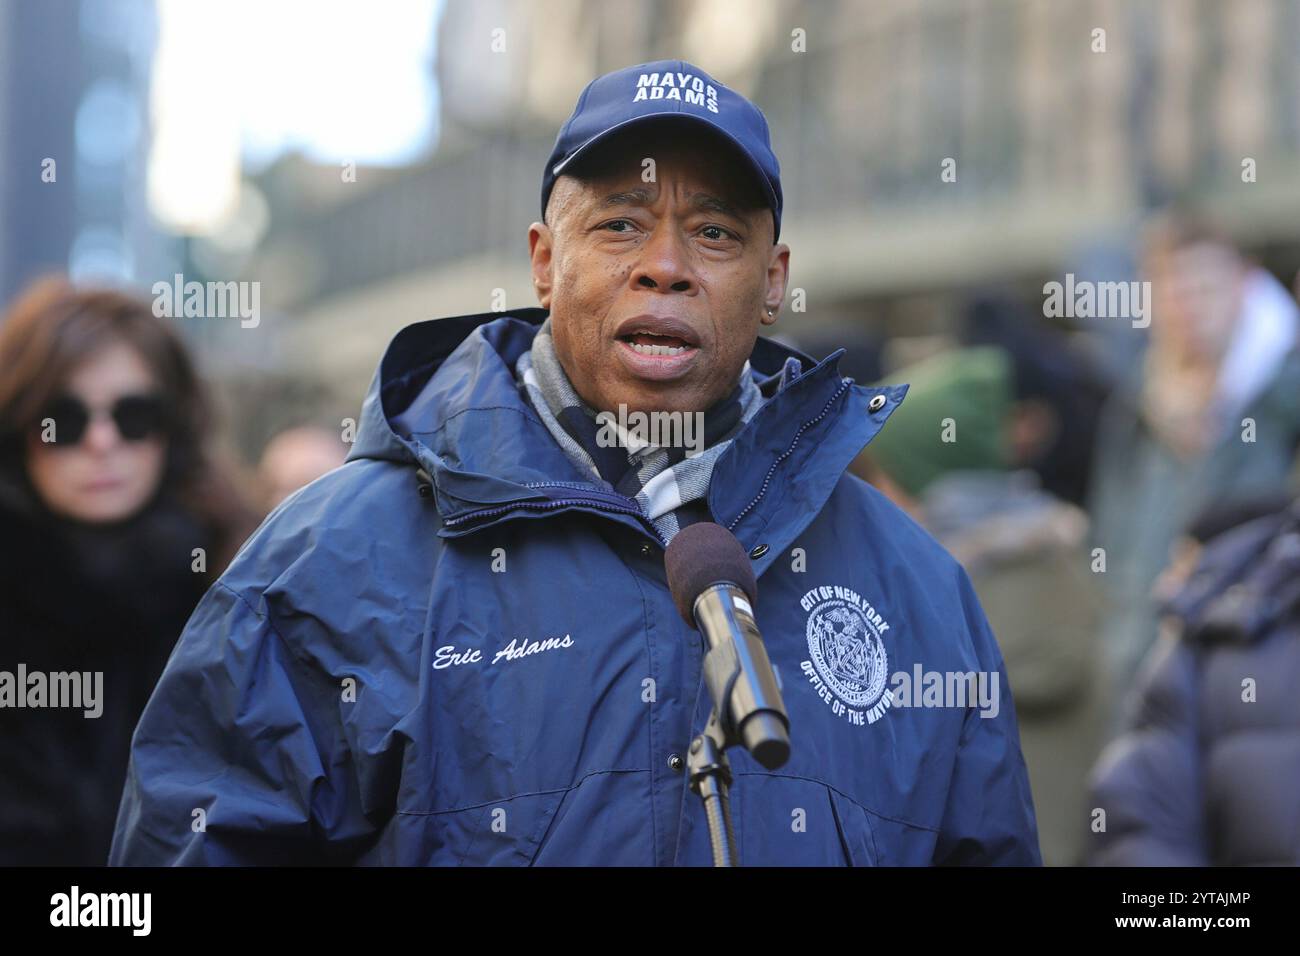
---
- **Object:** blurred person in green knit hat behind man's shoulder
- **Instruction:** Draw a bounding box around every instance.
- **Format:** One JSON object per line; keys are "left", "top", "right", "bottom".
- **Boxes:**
{"left": 854, "top": 346, "right": 1106, "bottom": 866}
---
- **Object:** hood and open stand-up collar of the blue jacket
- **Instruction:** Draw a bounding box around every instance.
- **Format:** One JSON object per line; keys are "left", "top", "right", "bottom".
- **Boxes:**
{"left": 348, "top": 308, "right": 907, "bottom": 564}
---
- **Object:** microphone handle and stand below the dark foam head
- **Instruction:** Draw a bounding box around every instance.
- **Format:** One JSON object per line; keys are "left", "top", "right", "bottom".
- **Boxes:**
{"left": 686, "top": 584, "right": 790, "bottom": 866}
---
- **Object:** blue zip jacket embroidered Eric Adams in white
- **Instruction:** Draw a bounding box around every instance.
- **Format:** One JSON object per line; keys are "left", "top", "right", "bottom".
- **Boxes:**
{"left": 109, "top": 308, "right": 1040, "bottom": 865}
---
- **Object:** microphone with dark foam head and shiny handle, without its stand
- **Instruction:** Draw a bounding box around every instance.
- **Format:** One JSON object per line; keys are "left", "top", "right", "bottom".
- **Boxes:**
{"left": 664, "top": 522, "right": 790, "bottom": 770}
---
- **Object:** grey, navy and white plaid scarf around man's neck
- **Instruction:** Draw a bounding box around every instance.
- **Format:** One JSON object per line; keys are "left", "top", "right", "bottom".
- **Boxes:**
{"left": 515, "top": 319, "right": 763, "bottom": 541}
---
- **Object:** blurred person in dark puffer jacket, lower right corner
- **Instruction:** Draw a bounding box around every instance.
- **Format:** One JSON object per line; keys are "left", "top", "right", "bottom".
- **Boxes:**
{"left": 1088, "top": 496, "right": 1300, "bottom": 866}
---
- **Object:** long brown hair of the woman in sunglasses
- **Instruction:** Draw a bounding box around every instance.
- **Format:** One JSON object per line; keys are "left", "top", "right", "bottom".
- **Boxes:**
{"left": 0, "top": 277, "right": 256, "bottom": 578}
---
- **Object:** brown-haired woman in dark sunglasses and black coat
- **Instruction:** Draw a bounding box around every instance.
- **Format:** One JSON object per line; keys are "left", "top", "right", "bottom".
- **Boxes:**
{"left": 0, "top": 278, "right": 255, "bottom": 865}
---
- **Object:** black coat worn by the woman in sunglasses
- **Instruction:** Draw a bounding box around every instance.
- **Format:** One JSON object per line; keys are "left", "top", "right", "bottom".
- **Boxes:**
{"left": 0, "top": 484, "right": 211, "bottom": 865}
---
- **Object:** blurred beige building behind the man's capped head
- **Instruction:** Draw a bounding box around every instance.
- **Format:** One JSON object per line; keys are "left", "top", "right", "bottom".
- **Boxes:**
{"left": 170, "top": 0, "right": 1300, "bottom": 395}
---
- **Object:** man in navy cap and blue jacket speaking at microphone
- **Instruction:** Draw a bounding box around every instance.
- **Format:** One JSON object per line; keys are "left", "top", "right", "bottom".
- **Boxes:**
{"left": 111, "top": 60, "right": 1040, "bottom": 865}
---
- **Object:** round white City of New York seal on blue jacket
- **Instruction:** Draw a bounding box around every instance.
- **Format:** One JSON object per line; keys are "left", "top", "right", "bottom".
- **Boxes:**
{"left": 800, "top": 585, "right": 893, "bottom": 726}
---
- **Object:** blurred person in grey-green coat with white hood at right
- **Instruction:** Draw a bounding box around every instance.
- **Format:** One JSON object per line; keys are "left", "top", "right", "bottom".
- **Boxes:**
{"left": 1091, "top": 213, "right": 1300, "bottom": 731}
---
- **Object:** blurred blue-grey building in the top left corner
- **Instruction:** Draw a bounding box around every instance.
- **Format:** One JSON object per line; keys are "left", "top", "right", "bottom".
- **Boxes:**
{"left": 0, "top": 0, "right": 166, "bottom": 302}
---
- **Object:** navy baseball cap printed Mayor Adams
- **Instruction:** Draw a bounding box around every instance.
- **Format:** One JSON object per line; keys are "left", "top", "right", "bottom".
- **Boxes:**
{"left": 542, "top": 60, "right": 781, "bottom": 242}
